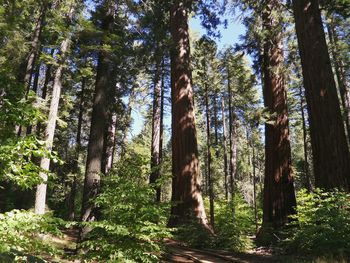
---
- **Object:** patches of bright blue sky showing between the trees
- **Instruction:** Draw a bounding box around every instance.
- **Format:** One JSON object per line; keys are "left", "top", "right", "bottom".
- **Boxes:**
{"left": 129, "top": 13, "right": 245, "bottom": 136}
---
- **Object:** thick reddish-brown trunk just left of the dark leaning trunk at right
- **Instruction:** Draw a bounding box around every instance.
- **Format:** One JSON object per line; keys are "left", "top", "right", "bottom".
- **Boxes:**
{"left": 262, "top": 0, "right": 296, "bottom": 228}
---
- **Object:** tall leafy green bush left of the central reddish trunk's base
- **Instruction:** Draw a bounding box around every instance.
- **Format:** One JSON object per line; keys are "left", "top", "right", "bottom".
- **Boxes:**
{"left": 83, "top": 153, "right": 170, "bottom": 262}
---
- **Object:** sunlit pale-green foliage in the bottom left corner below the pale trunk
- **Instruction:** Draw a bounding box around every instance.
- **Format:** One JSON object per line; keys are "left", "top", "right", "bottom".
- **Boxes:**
{"left": 0, "top": 210, "right": 62, "bottom": 262}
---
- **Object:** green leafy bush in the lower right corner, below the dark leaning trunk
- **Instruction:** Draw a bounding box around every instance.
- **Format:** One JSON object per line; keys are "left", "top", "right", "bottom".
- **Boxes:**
{"left": 284, "top": 189, "right": 350, "bottom": 256}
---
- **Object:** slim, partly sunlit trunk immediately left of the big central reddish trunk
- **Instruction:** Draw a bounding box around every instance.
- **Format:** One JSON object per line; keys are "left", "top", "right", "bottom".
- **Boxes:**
{"left": 149, "top": 51, "right": 163, "bottom": 202}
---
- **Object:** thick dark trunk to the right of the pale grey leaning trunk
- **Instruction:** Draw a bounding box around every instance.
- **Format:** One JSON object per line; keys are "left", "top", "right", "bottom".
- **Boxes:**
{"left": 79, "top": 1, "right": 116, "bottom": 229}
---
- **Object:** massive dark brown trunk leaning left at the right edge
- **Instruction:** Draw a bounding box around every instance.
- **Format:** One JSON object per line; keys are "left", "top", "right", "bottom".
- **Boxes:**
{"left": 293, "top": 0, "right": 350, "bottom": 190}
